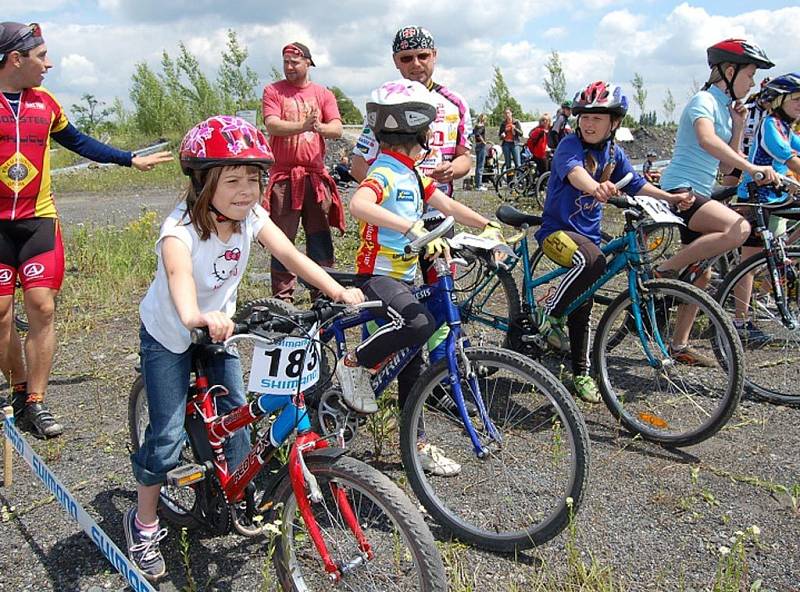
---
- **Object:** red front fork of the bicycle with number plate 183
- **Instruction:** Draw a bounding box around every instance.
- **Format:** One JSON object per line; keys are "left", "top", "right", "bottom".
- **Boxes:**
{"left": 289, "top": 432, "right": 375, "bottom": 582}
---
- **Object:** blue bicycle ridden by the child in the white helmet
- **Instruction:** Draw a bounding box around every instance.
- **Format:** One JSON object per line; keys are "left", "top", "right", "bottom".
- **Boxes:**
{"left": 245, "top": 218, "right": 589, "bottom": 551}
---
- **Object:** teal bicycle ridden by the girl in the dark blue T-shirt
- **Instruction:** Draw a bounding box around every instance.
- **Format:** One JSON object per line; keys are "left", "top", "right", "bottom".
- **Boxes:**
{"left": 459, "top": 178, "right": 744, "bottom": 447}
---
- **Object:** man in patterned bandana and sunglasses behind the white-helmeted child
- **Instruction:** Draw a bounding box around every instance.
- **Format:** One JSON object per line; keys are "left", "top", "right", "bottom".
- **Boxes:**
{"left": 351, "top": 26, "right": 472, "bottom": 197}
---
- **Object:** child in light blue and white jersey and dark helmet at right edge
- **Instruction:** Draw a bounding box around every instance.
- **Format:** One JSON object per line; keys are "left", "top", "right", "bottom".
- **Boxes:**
{"left": 733, "top": 72, "right": 800, "bottom": 347}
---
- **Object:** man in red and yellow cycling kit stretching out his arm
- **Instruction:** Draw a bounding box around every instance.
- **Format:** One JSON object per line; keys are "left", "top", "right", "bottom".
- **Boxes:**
{"left": 0, "top": 22, "right": 172, "bottom": 438}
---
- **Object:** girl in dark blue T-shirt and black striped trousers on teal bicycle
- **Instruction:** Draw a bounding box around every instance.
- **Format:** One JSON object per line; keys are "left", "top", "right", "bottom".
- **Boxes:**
{"left": 535, "top": 82, "right": 694, "bottom": 403}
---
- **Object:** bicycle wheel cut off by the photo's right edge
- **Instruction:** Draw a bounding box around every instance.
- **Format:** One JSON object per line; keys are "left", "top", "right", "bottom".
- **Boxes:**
{"left": 717, "top": 247, "right": 800, "bottom": 405}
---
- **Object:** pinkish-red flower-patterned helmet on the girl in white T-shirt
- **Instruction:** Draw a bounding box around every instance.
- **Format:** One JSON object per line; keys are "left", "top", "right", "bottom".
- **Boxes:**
{"left": 180, "top": 115, "right": 275, "bottom": 175}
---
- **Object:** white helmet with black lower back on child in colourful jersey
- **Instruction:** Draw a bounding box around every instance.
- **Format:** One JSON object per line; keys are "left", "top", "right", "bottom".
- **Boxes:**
{"left": 367, "top": 78, "right": 436, "bottom": 140}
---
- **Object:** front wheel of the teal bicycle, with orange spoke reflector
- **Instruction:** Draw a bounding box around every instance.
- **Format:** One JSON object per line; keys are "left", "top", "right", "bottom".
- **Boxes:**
{"left": 592, "top": 280, "right": 744, "bottom": 447}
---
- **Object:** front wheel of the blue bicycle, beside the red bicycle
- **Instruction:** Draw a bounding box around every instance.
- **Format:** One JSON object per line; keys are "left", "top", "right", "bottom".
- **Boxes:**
{"left": 400, "top": 348, "right": 589, "bottom": 552}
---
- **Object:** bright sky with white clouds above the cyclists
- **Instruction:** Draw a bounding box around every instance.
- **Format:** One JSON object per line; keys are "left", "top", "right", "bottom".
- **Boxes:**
{"left": 0, "top": 0, "right": 800, "bottom": 119}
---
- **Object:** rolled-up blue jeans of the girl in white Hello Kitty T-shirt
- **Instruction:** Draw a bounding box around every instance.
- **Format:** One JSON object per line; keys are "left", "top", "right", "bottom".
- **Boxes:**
{"left": 131, "top": 326, "right": 250, "bottom": 485}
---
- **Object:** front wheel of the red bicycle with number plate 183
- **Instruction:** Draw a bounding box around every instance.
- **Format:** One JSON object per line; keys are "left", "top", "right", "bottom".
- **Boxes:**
{"left": 268, "top": 455, "right": 447, "bottom": 592}
